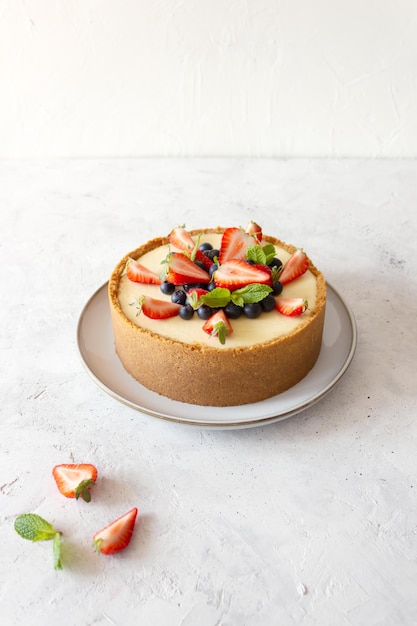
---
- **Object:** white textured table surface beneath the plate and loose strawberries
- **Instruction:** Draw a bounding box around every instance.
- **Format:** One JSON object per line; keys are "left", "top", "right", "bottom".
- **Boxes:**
{"left": 0, "top": 159, "right": 417, "bottom": 626}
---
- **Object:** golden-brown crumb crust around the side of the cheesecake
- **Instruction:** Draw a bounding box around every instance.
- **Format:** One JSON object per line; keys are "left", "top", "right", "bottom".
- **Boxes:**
{"left": 108, "top": 227, "right": 326, "bottom": 406}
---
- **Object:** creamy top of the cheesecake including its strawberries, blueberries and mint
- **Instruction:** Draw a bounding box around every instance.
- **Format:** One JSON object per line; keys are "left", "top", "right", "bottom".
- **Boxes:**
{"left": 111, "top": 222, "right": 322, "bottom": 347}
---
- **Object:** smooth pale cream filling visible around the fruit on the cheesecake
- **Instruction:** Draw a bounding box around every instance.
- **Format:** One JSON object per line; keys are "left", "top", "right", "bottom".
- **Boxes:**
{"left": 118, "top": 233, "right": 317, "bottom": 350}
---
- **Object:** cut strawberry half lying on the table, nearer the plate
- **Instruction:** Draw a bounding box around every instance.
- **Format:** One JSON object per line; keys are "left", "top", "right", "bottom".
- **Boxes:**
{"left": 52, "top": 463, "right": 97, "bottom": 502}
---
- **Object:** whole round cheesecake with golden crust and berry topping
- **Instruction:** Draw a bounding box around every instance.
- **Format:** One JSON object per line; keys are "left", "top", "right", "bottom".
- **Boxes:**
{"left": 108, "top": 222, "right": 326, "bottom": 406}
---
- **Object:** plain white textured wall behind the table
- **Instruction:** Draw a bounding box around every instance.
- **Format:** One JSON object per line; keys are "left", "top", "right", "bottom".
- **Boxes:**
{"left": 0, "top": 0, "right": 417, "bottom": 158}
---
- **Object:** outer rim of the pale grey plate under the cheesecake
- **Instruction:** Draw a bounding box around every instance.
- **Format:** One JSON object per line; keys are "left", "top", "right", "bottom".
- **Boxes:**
{"left": 76, "top": 281, "right": 358, "bottom": 430}
